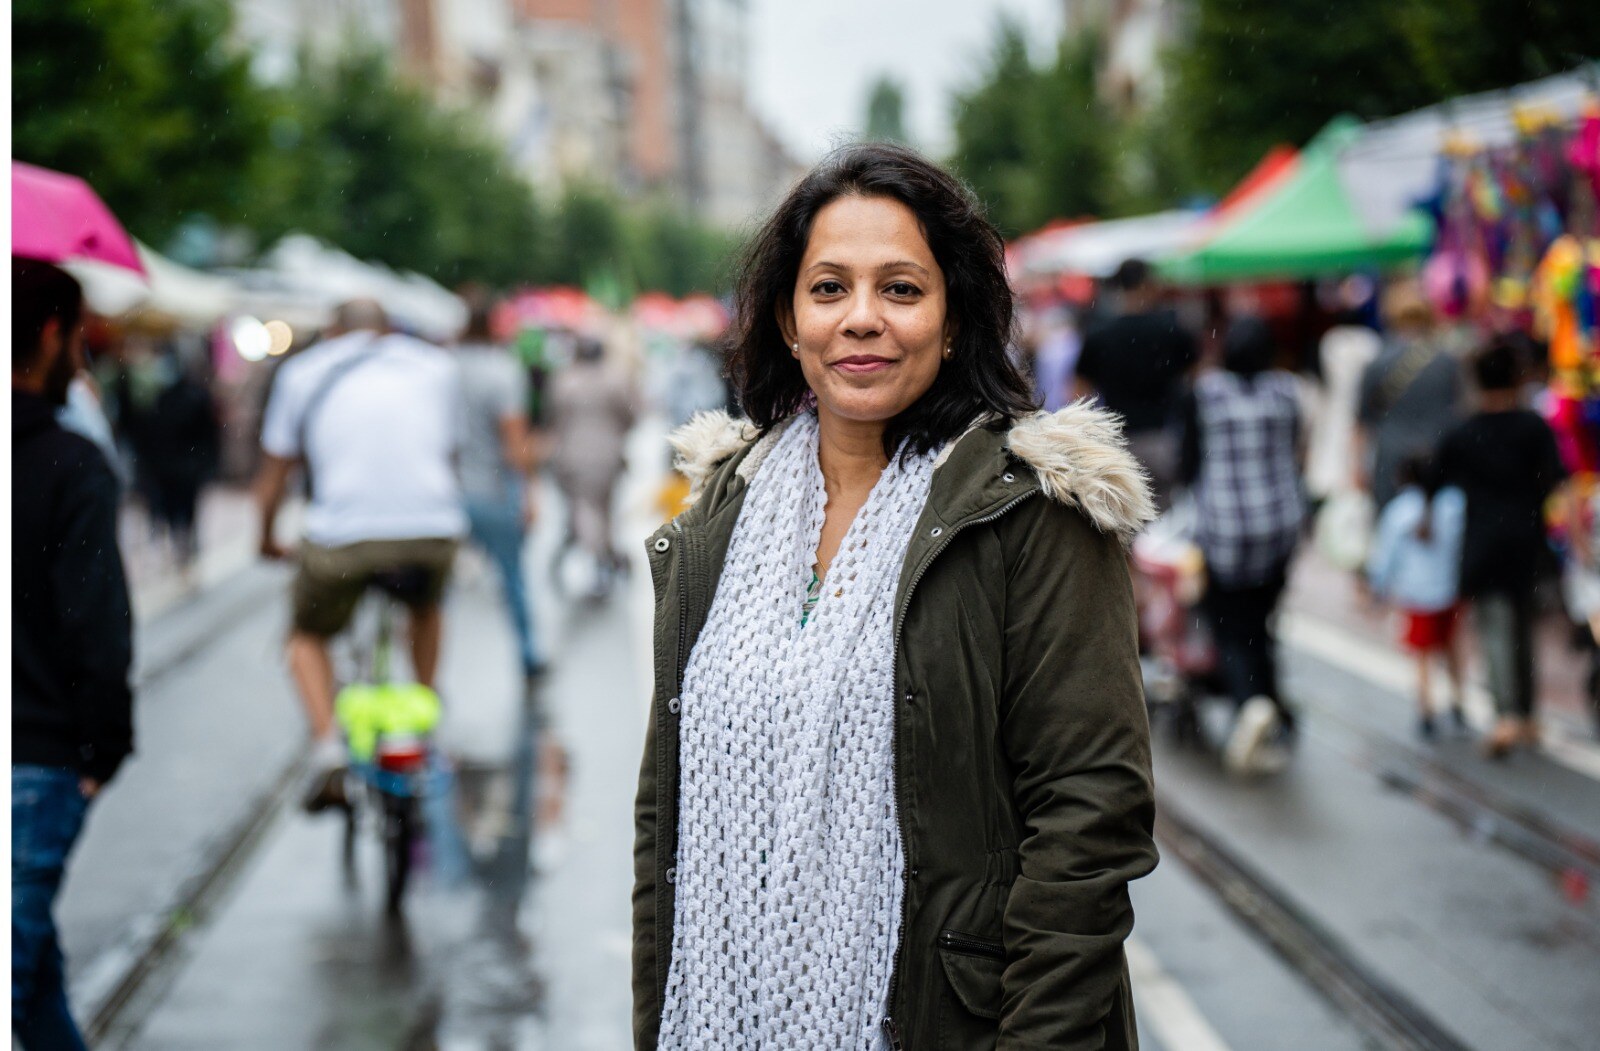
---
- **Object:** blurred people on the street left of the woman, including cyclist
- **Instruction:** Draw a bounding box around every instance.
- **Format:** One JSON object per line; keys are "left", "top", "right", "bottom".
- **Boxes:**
{"left": 11, "top": 258, "right": 649, "bottom": 1048}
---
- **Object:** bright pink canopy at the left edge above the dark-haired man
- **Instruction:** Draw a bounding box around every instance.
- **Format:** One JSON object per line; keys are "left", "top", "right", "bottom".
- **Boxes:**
{"left": 11, "top": 160, "right": 144, "bottom": 274}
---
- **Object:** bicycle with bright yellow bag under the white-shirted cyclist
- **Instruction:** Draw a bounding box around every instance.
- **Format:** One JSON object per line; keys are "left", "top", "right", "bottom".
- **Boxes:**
{"left": 334, "top": 569, "right": 443, "bottom": 915}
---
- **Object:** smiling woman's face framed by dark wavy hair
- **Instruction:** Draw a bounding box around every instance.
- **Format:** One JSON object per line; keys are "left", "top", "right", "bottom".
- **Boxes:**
{"left": 779, "top": 197, "right": 950, "bottom": 424}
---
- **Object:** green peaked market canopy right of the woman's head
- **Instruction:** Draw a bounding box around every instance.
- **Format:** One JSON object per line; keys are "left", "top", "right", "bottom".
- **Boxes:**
{"left": 1157, "top": 117, "right": 1434, "bottom": 285}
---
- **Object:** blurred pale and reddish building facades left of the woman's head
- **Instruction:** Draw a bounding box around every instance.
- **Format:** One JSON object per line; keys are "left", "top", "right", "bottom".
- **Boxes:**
{"left": 234, "top": 0, "right": 802, "bottom": 226}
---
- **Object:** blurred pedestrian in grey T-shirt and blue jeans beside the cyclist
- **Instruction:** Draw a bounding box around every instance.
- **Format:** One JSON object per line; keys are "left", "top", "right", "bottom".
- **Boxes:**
{"left": 456, "top": 290, "right": 544, "bottom": 680}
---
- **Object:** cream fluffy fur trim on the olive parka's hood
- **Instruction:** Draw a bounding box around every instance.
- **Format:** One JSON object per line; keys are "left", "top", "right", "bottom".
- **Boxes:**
{"left": 672, "top": 400, "right": 1155, "bottom": 544}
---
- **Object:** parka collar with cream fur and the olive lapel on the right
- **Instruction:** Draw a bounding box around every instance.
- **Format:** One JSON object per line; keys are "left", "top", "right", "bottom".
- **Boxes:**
{"left": 672, "top": 402, "right": 1155, "bottom": 544}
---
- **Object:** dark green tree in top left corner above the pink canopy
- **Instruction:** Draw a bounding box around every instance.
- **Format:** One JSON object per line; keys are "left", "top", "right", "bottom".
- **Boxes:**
{"left": 11, "top": 0, "right": 270, "bottom": 242}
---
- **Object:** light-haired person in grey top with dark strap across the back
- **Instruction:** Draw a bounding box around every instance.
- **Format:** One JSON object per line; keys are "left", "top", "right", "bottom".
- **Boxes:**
{"left": 1355, "top": 278, "right": 1462, "bottom": 507}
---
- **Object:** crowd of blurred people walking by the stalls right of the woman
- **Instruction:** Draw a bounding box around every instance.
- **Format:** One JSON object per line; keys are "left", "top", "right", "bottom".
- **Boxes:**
{"left": 1026, "top": 259, "right": 1600, "bottom": 768}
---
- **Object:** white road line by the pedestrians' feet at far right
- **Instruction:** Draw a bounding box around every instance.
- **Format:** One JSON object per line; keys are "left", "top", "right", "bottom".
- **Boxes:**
{"left": 1278, "top": 611, "right": 1600, "bottom": 781}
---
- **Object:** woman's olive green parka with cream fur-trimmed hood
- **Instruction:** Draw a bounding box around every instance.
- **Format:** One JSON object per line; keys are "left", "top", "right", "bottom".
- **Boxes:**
{"left": 634, "top": 403, "right": 1157, "bottom": 1051}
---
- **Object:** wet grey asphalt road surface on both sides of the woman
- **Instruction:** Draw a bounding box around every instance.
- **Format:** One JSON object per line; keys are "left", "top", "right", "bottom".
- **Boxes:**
{"left": 62, "top": 425, "right": 1600, "bottom": 1051}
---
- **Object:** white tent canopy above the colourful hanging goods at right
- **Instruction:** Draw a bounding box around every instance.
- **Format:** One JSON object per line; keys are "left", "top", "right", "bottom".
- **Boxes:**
{"left": 1339, "top": 66, "right": 1600, "bottom": 237}
